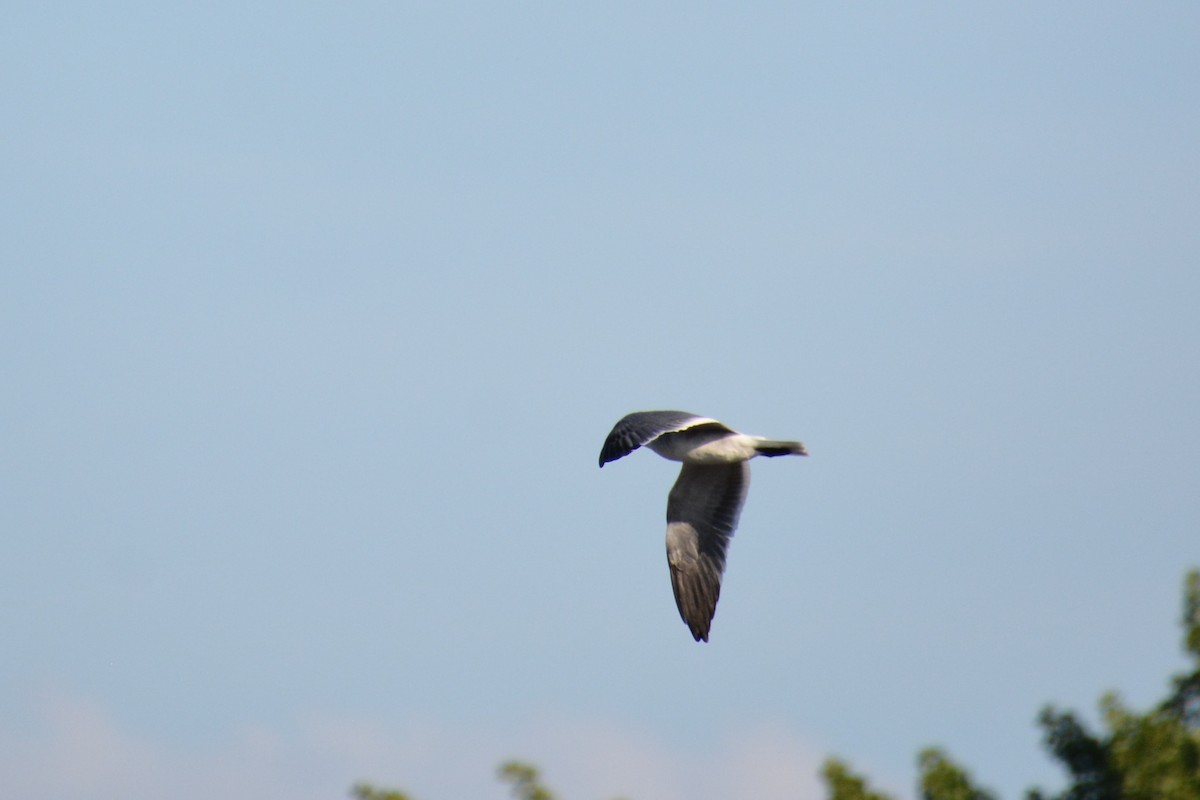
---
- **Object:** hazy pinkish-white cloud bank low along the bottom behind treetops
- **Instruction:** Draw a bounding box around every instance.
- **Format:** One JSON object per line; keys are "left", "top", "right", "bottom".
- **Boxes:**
{"left": 0, "top": 694, "right": 823, "bottom": 800}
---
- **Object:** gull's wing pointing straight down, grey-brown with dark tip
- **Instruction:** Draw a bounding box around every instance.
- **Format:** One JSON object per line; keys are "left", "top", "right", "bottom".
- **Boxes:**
{"left": 667, "top": 462, "right": 750, "bottom": 642}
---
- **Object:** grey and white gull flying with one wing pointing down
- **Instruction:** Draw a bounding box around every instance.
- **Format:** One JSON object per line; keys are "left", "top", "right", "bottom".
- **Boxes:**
{"left": 600, "top": 411, "right": 809, "bottom": 642}
